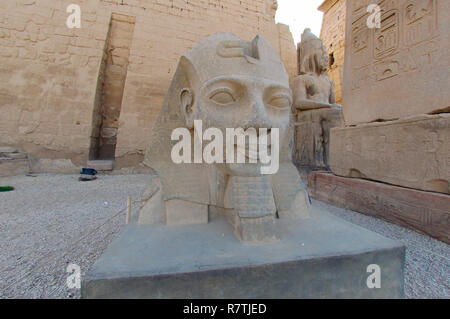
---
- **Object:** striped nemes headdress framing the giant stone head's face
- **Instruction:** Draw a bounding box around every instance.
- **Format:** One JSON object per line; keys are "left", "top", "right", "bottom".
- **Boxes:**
{"left": 144, "top": 33, "right": 306, "bottom": 215}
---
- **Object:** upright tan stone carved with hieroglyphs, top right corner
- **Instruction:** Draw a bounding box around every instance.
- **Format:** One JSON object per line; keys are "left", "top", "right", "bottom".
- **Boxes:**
{"left": 343, "top": 0, "right": 450, "bottom": 125}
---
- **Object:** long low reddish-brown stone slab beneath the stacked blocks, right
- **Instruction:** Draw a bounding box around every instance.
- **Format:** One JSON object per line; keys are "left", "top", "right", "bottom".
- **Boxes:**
{"left": 308, "top": 172, "right": 450, "bottom": 244}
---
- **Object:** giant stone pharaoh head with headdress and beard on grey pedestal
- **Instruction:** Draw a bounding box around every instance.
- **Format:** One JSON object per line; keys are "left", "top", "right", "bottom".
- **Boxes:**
{"left": 141, "top": 33, "right": 309, "bottom": 241}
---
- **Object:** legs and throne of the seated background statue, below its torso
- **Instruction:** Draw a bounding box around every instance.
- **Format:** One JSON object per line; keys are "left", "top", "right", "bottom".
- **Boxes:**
{"left": 292, "top": 107, "right": 343, "bottom": 168}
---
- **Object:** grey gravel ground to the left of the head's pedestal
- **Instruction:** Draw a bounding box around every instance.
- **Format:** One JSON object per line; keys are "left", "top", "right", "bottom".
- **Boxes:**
{"left": 0, "top": 175, "right": 151, "bottom": 298}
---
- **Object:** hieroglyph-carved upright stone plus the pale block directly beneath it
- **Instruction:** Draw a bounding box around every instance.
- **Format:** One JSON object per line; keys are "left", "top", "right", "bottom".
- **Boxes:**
{"left": 330, "top": 0, "right": 450, "bottom": 194}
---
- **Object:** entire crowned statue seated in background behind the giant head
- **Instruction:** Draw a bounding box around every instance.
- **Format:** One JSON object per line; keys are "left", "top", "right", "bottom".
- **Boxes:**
{"left": 293, "top": 29, "right": 342, "bottom": 168}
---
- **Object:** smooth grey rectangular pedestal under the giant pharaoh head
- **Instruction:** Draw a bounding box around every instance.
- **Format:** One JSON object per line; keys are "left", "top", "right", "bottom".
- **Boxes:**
{"left": 82, "top": 208, "right": 405, "bottom": 298}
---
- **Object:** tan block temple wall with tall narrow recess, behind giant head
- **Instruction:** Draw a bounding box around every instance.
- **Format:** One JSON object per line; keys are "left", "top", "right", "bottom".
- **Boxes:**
{"left": 0, "top": 0, "right": 296, "bottom": 169}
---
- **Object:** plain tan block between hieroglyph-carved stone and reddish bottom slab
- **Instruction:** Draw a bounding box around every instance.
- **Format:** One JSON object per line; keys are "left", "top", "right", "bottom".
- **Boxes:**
{"left": 330, "top": 114, "right": 450, "bottom": 194}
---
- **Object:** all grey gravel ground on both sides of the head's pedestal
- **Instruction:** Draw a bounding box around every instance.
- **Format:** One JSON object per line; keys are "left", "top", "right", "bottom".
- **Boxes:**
{"left": 0, "top": 174, "right": 450, "bottom": 298}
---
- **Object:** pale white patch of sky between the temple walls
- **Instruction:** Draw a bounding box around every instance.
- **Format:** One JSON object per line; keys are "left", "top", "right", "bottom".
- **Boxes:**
{"left": 275, "top": 0, "right": 324, "bottom": 43}
